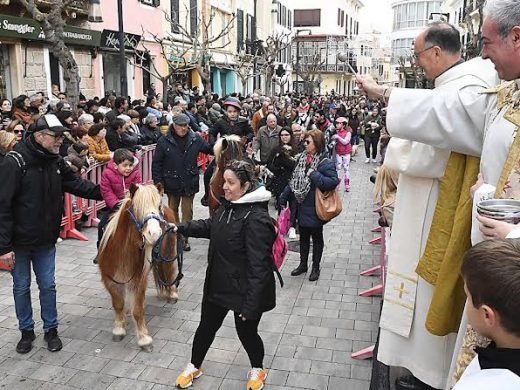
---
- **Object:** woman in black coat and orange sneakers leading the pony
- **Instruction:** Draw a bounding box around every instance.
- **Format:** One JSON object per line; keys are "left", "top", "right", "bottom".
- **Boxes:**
{"left": 176, "top": 160, "right": 276, "bottom": 389}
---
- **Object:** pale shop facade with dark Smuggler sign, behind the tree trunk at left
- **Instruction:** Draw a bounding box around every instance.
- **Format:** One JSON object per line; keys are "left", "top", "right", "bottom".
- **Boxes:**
{"left": 0, "top": 1, "right": 101, "bottom": 99}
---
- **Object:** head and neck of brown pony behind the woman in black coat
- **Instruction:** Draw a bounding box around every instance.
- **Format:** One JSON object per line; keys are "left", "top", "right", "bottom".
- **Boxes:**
{"left": 208, "top": 135, "right": 244, "bottom": 216}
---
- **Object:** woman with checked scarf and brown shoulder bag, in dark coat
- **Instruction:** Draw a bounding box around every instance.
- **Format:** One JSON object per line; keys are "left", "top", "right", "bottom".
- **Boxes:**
{"left": 280, "top": 130, "right": 339, "bottom": 282}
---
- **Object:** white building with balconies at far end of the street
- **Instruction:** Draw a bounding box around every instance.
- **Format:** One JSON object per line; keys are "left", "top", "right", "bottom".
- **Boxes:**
{"left": 292, "top": 0, "right": 363, "bottom": 94}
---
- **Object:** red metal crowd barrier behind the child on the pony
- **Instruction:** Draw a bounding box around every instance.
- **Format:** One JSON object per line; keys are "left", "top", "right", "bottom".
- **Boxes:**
{"left": 60, "top": 145, "right": 155, "bottom": 241}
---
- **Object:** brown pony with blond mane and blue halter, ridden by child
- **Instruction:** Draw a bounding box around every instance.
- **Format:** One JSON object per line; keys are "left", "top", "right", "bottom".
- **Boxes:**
{"left": 98, "top": 184, "right": 178, "bottom": 351}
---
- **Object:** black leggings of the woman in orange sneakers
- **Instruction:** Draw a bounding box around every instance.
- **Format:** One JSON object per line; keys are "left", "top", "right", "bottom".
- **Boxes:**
{"left": 191, "top": 300, "right": 264, "bottom": 368}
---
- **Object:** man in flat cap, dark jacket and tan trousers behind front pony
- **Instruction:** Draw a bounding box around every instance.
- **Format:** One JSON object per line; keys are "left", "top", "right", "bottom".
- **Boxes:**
{"left": 152, "top": 114, "right": 211, "bottom": 251}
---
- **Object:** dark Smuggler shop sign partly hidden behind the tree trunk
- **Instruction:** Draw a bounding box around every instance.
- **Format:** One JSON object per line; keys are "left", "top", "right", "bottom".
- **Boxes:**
{"left": 0, "top": 15, "right": 101, "bottom": 46}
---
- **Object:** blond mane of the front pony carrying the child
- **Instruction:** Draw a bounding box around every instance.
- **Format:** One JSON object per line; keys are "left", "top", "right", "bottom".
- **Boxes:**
{"left": 99, "top": 184, "right": 161, "bottom": 250}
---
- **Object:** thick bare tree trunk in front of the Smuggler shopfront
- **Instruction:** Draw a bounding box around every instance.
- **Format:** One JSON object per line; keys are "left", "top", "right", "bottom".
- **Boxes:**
{"left": 18, "top": 0, "right": 81, "bottom": 107}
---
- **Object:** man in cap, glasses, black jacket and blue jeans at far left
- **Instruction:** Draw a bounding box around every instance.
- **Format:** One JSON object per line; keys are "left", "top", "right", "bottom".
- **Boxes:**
{"left": 0, "top": 115, "right": 102, "bottom": 353}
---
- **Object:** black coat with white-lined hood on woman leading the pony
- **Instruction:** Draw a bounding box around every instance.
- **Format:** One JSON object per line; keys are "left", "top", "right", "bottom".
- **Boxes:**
{"left": 178, "top": 187, "right": 276, "bottom": 319}
